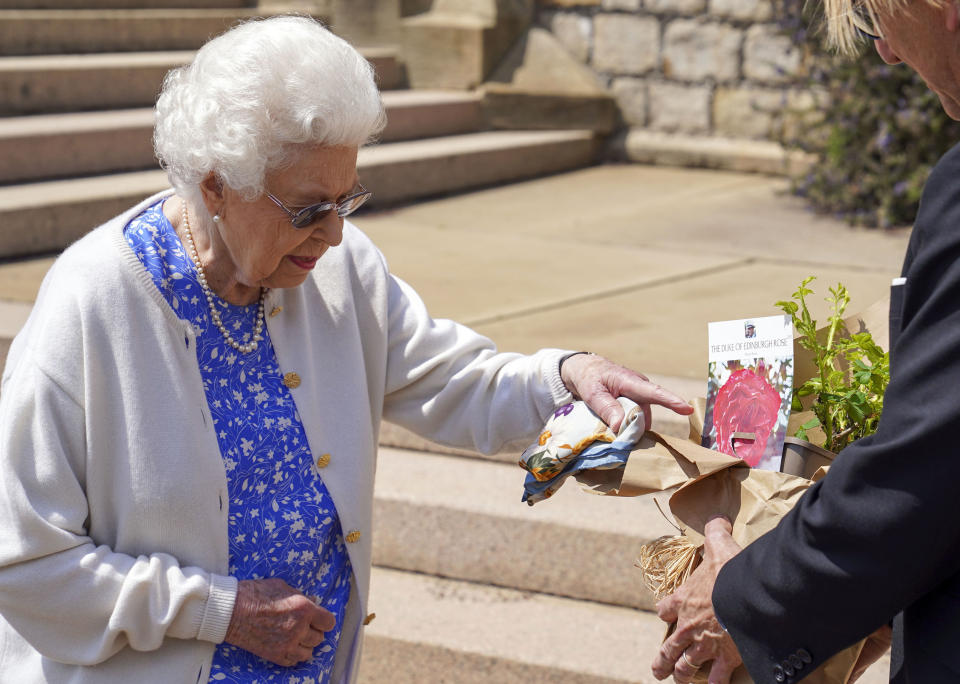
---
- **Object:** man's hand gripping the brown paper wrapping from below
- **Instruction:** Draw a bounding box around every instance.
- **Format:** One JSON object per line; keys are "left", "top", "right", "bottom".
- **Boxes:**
{"left": 653, "top": 516, "right": 743, "bottom": 684}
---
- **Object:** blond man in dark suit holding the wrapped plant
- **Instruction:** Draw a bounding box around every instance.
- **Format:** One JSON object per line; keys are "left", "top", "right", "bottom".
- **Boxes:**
{"left": 653, "top": 0, "right": 960, "bottom": 684}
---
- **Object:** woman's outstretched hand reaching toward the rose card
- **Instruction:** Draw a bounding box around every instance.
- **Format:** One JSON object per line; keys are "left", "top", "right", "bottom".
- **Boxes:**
{"left": 560, "top": 354, "right": 693, "bottom": 432}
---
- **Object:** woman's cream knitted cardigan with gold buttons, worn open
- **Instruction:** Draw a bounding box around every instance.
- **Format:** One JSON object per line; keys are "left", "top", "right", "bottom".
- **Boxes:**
{"left": 0, "top": 191, "right": 571, "bottom": 684}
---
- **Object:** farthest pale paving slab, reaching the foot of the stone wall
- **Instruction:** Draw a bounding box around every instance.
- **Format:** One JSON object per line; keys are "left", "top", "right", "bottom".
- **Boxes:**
{"left": 358, "top": 164, "right": 909, "bottom": 271}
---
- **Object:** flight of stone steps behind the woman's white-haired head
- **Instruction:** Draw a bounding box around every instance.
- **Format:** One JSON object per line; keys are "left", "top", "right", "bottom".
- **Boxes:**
{"left": 0, "top": 0, "right": 599, "bottom": 258}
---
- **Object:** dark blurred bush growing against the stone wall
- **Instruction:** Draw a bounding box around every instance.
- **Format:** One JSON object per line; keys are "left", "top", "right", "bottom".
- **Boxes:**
{"left": 778, "top": 0, "right": 960, "bottom": 228}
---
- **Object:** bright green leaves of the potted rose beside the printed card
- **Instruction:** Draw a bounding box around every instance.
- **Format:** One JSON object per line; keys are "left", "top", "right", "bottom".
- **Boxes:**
{"left": 777, "top": 276, "right": 890, "bottom": 452}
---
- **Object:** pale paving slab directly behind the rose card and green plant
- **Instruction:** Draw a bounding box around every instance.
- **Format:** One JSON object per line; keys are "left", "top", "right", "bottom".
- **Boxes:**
{"left": 472, "top": 261, "right": 892, "bottom": 382}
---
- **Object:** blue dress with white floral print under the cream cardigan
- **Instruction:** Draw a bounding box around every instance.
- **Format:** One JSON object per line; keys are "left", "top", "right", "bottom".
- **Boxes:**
{"left": 124, "top": 200, "right": 351, "bottom": 684}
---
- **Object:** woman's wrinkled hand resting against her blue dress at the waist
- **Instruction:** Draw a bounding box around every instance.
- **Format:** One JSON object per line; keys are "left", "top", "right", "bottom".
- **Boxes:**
{"left": 225, "top": 579, "right": 336, "bottom": 667}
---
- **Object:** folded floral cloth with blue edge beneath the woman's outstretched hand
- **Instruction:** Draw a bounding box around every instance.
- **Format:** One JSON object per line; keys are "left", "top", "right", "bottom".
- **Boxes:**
{"left": 520, "top": 397, "right": 646, "bottom": 506}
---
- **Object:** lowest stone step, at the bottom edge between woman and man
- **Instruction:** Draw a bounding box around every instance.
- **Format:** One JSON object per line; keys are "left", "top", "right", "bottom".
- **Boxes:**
{"left": 360, "top": 559, "right": 664, "bottom": 684}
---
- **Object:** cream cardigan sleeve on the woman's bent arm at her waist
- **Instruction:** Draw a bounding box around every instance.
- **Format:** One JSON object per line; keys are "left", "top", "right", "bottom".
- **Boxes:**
{"left": 0, "top": 350, "right": 236, "bottom": 665}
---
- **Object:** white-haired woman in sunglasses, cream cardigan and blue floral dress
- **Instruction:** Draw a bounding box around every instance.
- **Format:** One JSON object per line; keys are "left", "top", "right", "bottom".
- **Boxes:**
{"left": 0, "top": 17, "right": 686, "bottom": 684}
